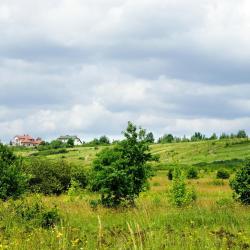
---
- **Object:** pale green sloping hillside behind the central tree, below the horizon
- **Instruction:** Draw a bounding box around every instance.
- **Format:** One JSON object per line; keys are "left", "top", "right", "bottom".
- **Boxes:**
{"left": 17, "top": 139, "right": 250, "bottom": 169}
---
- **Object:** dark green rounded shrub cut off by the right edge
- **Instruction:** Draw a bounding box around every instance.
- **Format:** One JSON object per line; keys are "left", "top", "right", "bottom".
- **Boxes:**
{"left": 230, "top": 161, "right": 250, "bottom": 205}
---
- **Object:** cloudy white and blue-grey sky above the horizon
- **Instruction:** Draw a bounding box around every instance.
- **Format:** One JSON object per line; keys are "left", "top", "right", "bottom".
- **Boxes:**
{"left": 0, "top": 0, "right": 250, "bottom": 141}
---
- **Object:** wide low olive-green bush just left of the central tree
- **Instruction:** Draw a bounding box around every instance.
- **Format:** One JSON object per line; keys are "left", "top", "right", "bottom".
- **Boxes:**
{"left": 25, "top": 159, "right": 86, "bottom": 195}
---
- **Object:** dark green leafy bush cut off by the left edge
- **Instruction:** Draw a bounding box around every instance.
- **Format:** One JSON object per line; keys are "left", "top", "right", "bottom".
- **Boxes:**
{"left": 0, "top": 144, "right": 28, "bottom": 200}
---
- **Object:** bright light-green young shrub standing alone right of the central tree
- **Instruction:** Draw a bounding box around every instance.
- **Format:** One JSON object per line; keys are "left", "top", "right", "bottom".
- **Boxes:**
{"left": 169, "top": 169, "right": 197, "bottom": 207}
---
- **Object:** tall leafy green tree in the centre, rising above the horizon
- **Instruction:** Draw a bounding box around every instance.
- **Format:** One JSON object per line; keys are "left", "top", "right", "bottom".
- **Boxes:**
{"left": 90, "top": 122, "right": 156, "bottom": 207}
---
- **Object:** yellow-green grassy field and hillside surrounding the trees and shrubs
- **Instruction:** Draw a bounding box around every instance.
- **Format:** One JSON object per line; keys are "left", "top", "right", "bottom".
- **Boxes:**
{"left": 0, "top": 139, "right": 250, "bottom": 250}
